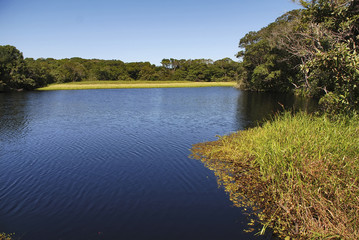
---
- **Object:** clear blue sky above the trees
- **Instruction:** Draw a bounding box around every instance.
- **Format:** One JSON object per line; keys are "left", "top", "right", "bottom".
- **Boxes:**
{"left": 0, "top": 0, "right": 299, "bottom": 65}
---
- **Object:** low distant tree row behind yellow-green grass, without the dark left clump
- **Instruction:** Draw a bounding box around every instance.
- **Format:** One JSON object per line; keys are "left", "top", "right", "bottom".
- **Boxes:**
{"left": 40, "top": 58, "right": 239, "bottom": 83}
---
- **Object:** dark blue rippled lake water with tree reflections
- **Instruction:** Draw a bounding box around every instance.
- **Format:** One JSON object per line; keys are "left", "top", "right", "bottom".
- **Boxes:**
{"left": 0, "top": 87, "right": 316, "bottom": 240}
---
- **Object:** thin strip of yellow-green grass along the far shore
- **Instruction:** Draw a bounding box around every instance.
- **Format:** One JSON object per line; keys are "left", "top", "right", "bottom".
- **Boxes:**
{"left": 37, "top": 81, "right": 236, "bottom": 91}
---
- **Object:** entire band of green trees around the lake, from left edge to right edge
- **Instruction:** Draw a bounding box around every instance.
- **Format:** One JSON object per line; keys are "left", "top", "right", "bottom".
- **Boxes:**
{"left": 0, "top": 0, "right": 359, "bottom": 111}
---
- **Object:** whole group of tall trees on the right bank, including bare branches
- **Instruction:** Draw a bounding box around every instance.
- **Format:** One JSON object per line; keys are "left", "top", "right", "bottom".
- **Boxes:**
{"left": 237, "top": 0, "right": 359, "bottom": 111}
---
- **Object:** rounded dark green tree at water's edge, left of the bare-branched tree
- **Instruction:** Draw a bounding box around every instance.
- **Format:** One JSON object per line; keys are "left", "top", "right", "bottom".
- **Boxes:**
{"left": 237, "top": 10, "right": 306, "bottom": 92}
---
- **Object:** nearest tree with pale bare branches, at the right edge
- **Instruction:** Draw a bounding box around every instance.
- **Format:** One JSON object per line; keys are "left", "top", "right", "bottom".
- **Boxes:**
{"left": 281, "top": 0, "right": 359, "bottom": 111}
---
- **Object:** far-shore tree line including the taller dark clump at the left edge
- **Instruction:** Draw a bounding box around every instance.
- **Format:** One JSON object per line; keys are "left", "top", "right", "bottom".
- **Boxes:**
{"left": 0, "top": 45, "right": 240, "bottom": 91}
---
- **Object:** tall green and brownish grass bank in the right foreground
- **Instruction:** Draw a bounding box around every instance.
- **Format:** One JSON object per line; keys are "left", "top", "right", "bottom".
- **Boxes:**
{"left": 192, "top": 113, "right": 359, "bottom": 239}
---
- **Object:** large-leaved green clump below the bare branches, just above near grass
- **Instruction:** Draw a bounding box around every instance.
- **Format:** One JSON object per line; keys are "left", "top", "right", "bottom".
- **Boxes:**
{"left": 307, "top": 43, "right": 359, "bottom": 112}
